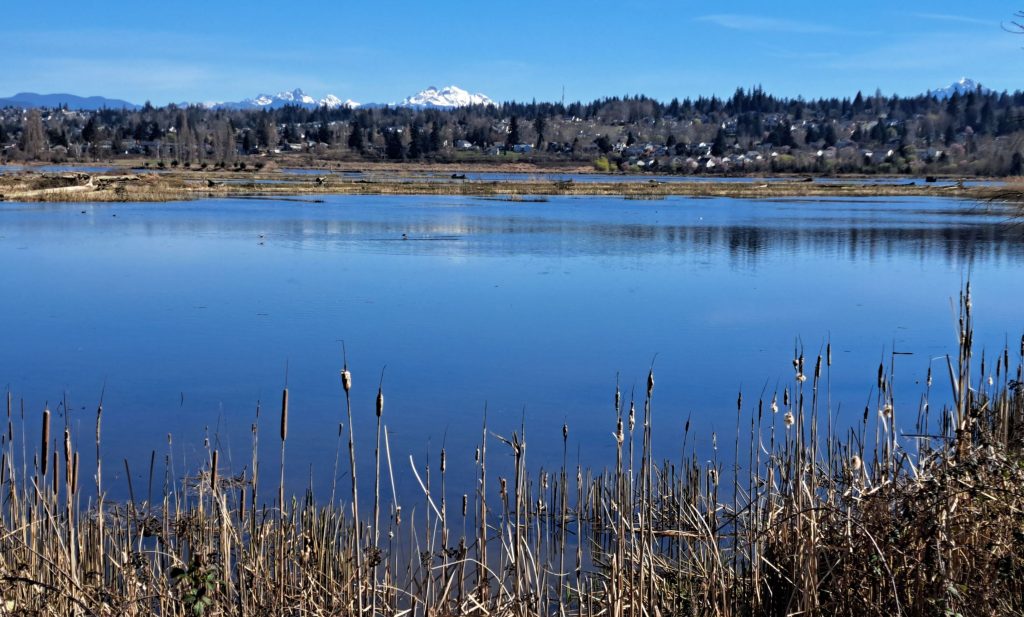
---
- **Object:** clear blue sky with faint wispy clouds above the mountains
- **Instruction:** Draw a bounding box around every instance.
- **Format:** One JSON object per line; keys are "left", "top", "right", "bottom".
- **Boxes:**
{"left": 0, "top": 0, "right": 1024, "bottom": 103}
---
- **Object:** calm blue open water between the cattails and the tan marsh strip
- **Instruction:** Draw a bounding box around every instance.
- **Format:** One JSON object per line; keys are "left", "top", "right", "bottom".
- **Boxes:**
{"left": 0, "top": 196, "right": 1024, "bottom": 492}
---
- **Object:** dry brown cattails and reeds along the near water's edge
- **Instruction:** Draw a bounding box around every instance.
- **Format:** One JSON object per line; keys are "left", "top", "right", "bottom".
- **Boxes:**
{"left": 0, "top": 288, "right": 1024, "bottom": 617}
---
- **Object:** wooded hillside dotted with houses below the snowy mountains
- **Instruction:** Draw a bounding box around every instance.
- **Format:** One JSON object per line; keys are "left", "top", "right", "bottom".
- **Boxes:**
{"left": 0, "top": 81, "right": 1024, "bottom": 177}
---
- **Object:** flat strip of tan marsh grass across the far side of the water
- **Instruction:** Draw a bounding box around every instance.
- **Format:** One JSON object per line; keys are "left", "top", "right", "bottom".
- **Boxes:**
{"left": 0, "top": 164, "right": 1007, "bottom": 203}
